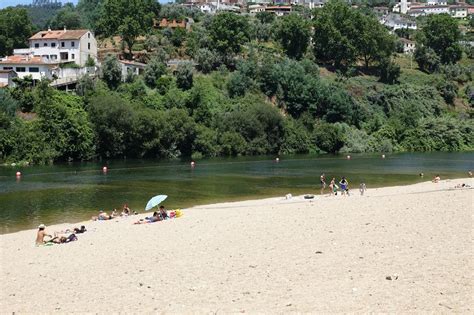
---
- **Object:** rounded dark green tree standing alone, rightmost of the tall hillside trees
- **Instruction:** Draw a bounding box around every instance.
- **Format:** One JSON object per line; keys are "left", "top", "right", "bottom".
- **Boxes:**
{"left": 416, "top": 14, "right": 462, "bottom": 64}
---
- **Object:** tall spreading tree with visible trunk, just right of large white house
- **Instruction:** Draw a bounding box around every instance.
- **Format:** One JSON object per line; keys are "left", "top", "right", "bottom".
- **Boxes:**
{"left": 98, "top": 0, "right": 160, "bottom": 56}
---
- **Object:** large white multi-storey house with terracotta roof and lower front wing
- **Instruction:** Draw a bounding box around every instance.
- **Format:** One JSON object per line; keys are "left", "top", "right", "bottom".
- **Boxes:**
{"left": 0, "top": 29, "right": 97, "bottom": 80}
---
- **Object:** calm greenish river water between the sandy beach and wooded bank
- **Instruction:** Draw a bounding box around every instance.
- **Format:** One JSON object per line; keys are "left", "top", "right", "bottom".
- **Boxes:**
{"left": 0, "top": 152, "right": 474, "bottom": 234}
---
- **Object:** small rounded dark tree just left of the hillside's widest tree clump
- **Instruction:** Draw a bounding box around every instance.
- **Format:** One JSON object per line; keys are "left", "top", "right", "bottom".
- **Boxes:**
{"left": 275, "top": 13, "right": 310, "bottom": 59}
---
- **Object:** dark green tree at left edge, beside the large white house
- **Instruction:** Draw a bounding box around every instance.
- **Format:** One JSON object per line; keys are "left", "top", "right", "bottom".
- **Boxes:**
{"left": 0, "top": 7, "right": 33, "bottom": 56}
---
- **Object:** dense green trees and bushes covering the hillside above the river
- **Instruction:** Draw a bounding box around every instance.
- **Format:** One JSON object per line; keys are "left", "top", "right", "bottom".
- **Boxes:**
{"left": 0, "top": 0, "right": 474, "bottom": 163}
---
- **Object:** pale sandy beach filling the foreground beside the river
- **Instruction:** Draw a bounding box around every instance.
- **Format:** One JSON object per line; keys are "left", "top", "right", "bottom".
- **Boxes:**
{"left": 0, "top": 179, "right": 474, "bottom": 314}
